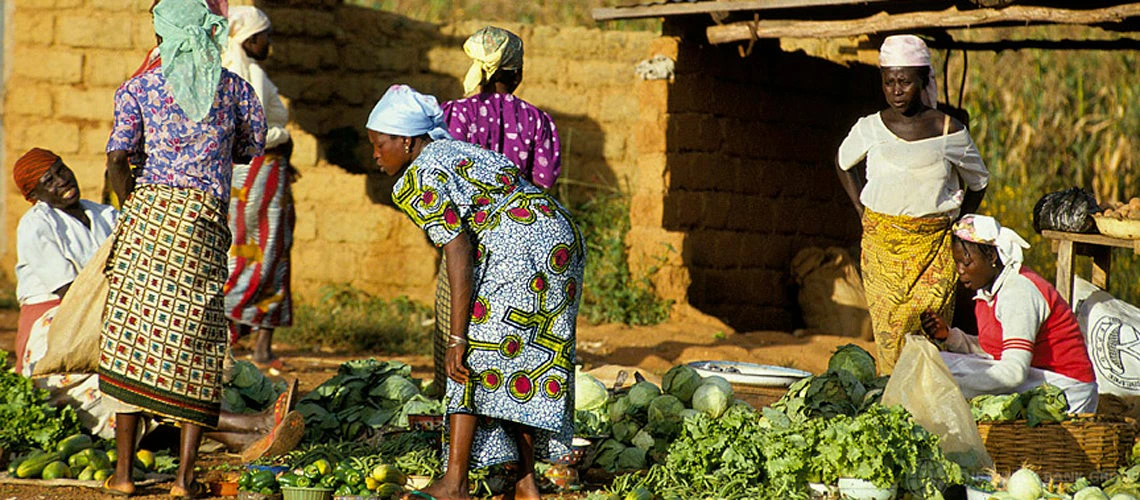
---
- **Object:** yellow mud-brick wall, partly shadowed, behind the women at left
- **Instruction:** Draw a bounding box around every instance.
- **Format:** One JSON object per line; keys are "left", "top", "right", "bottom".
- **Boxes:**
{"left": 0, "top": 0, "right": 654, "bottom": 302}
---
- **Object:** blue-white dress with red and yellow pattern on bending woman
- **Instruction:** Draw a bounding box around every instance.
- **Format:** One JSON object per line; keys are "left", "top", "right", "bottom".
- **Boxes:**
{"left": 392, "top": 140, "right": 586, "bottom": 468}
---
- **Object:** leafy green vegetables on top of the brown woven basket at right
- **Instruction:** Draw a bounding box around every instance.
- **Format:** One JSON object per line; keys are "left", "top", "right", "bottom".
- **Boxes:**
{"left": 970, "top": 384, "right": 1069, "bottom": 427}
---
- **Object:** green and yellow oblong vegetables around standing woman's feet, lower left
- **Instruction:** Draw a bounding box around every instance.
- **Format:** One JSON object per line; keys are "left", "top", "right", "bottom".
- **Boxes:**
{"left": 8, "top": 434, "right": 166, "bottom": 481}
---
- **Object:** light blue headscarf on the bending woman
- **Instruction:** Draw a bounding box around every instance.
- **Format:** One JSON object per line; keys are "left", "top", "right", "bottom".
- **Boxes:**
{"left": 366, "top": 84, "right": 451, "bottom": 140}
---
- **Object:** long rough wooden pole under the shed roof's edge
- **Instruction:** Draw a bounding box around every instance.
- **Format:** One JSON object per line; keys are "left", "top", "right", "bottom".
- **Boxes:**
{"left": 707, "top": 3, "right": 1140, "bottom": 43}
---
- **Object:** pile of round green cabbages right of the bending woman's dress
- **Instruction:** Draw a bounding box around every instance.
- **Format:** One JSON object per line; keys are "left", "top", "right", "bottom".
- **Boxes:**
{"left": 575, "top": 366, "right": 744, "bottom": 473}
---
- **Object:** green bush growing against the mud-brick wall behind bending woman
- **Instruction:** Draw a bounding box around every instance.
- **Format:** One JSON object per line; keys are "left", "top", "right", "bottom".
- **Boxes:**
{"left": 568, "top": 191, "right": 673, "bottom": 325}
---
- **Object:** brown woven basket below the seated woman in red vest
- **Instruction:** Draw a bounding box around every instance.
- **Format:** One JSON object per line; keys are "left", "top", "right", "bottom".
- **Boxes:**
{"left": 978, "top": 416, "right": 1135, "bottom": 482}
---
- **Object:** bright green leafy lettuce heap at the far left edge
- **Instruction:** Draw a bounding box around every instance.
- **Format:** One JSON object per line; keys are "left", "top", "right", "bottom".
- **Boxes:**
{"left": 0, "top": 350, "right": 80, "bottom": 453}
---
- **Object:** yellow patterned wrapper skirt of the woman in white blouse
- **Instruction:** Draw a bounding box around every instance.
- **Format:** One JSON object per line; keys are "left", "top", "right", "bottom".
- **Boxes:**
{"left": 862, "top": 210, "right": 958, "bottom": 375}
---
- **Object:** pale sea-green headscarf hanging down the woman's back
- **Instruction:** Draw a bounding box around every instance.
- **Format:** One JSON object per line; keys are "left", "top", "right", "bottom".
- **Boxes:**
{"left": 154, "top": 0, "right": 229, "bottom": 122}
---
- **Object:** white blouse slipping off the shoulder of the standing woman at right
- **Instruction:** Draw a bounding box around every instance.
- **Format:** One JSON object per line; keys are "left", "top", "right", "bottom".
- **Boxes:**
{"left": 837, "top": 113, "right": 990, "bottom": 218}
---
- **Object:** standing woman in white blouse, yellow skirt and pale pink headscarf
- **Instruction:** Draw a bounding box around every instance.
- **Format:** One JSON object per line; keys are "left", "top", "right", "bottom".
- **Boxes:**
{"left": 837, "top": 35, "right": 988, "bottom": 374}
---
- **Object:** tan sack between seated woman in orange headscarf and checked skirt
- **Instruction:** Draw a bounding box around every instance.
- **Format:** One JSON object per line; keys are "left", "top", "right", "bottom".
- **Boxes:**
{"left": 32, "top": 234, "right": 115, "bottom": 375}
